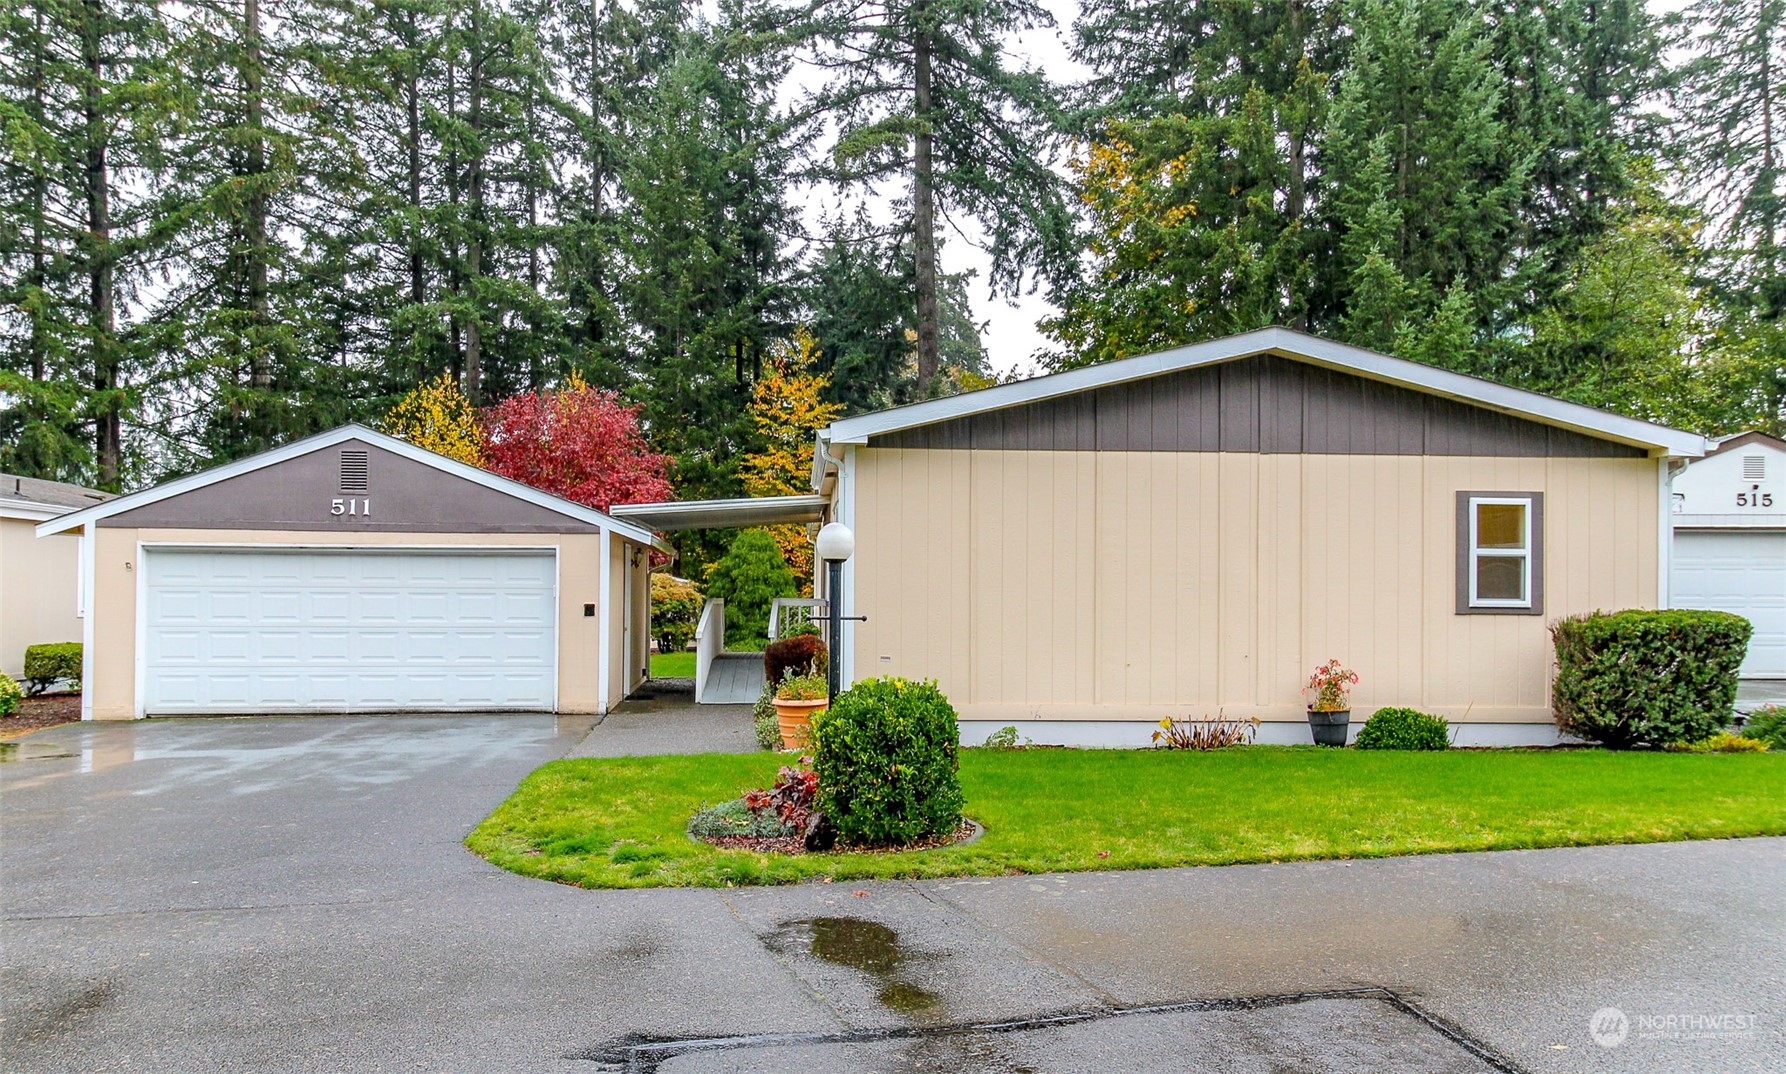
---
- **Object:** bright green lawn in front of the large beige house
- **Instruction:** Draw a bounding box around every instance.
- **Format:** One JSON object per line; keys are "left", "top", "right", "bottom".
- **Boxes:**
{"left": 466, "top": 747, "right": 1786, "bottom": 888}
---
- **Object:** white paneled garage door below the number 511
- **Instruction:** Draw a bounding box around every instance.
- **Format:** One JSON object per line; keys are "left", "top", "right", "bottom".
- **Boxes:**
{"left": 143, "top": 549, "right": 557, "bottom": 715}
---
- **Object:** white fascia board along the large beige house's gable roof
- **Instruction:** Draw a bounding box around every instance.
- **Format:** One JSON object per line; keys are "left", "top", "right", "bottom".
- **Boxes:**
{"left": 823, "top": 329, "right": 1706, "bottom": 457}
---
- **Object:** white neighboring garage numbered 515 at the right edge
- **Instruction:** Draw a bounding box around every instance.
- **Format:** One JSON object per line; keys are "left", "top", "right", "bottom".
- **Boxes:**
{"left": 1668, "top": 432, "right": 1786, "bottom": 709}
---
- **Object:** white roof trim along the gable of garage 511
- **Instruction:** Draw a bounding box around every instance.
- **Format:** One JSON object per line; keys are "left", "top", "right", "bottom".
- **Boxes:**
{"left": 38, "top": 424, "right": 670, "bottom": 552}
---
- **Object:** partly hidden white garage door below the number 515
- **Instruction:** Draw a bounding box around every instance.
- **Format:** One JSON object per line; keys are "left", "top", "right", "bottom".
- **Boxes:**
{"left": 1670, "top": 529, "right": 1786, "bottom": 679}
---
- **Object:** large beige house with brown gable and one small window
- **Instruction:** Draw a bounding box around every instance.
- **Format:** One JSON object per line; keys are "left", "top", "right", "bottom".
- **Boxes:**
{"left": 813, "top": 329, "right": 1706, "bottom": 743}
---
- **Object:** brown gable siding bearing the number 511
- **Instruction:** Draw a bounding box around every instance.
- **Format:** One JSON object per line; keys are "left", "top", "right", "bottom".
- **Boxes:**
{"left": 98, "top": 440, "right": 598, "bottom": 533}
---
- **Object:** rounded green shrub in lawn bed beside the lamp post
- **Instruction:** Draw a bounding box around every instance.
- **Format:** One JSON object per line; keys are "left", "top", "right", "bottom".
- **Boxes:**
{"left": 813, "top": 679, "right": 963, "bottom": 847}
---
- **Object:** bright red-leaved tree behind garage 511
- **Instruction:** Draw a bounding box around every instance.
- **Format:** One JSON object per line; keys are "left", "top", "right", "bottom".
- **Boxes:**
{"left": 484, "top": 373, "right": 675, "bottom": 511}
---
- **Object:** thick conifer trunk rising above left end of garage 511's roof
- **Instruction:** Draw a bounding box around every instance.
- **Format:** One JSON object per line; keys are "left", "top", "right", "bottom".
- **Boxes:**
{"left": 80, "top": 0, "right": 123, "bottom": 490}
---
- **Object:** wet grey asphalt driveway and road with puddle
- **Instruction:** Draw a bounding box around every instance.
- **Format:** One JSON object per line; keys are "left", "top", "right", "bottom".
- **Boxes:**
{"left": 0, "top": 713, "right": 1786, "bottom": 1072}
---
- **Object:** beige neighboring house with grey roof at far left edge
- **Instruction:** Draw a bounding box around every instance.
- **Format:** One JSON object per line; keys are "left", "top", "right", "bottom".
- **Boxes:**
{"left": 0, "top": 474, "right": 111, "bottom": 677}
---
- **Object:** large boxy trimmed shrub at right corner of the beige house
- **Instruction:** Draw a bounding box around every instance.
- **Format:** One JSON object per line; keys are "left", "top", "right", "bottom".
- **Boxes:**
{"left": 1550, "top": 611, "right": 1752, "bottom": 749}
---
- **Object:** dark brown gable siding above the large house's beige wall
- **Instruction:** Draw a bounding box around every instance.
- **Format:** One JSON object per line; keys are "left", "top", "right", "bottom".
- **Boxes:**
{"left": 870, "top": 354, "right": 1645, "bottom": 459}
